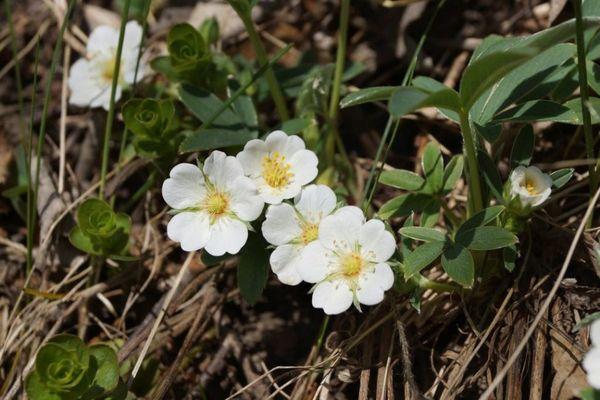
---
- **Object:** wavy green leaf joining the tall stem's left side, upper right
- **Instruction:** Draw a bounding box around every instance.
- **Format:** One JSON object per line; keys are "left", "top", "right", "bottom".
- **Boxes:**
{"left": 388, "top": 86, "right": 460, "bottom": 118}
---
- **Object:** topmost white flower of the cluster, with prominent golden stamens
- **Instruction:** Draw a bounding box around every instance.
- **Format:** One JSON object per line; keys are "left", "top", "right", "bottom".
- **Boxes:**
{"left": 237, "top": 131, "right": 318, "bottom": 204}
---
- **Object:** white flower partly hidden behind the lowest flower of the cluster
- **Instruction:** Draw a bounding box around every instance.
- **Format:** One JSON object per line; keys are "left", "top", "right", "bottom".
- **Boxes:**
{"left": 262, "top": 185, "right": 336, "bottom": 285}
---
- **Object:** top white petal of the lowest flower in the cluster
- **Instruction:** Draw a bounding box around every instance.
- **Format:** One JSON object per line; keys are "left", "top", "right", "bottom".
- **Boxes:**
{"left": 319, "top": 206, "right": 364, "bottom": 252}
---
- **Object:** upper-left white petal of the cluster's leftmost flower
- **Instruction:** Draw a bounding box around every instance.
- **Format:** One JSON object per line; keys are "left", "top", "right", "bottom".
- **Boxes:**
{"left": 162, "top": 163, "right": 206, "bottom": 210}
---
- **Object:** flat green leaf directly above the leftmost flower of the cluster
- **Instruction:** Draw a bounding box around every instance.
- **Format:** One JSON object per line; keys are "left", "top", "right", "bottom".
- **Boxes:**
{"left": 179, "top": 128, "right": 254, "bottom": 153}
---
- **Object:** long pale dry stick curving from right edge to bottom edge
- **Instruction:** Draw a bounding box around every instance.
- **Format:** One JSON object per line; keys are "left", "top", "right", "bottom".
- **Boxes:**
{"left": 479, "top": 186, "right": 600, "bottom": 400}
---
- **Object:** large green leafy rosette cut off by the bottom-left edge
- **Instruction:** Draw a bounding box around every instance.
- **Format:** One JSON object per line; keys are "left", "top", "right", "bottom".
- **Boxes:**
{"left": 25, "top": 334, "right": 119, "bottom": 400}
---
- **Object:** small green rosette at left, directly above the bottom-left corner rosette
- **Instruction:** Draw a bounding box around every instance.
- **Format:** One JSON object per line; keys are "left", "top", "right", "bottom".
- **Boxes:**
{"left": 69, "top": 199, "right": 131, "bottom": 257}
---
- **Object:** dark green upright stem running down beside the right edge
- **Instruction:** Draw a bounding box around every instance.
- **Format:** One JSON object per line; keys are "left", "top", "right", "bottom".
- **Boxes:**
{"left": 573, "top": 0, "right": 598, "bottom": 227}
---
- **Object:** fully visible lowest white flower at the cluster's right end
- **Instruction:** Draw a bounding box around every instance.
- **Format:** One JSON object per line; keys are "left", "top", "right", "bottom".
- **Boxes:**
{"left": 298, "top": 206, "right": 396, "bottom": 314}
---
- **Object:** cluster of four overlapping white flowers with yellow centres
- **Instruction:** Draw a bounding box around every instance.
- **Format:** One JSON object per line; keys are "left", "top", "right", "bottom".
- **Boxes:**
{"left": 162, "top": 131, "right": 396, "bottom": 314}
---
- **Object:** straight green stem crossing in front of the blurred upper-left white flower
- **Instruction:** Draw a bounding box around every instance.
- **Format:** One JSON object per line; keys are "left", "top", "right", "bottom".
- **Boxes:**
{"left": 99, "top": 0, "right": 131, "bottom": 198}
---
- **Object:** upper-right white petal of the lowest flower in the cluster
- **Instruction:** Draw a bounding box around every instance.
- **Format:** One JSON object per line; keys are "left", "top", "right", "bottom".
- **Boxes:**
{"left": 359, "top": 219, "right": 396, "bottom": 262}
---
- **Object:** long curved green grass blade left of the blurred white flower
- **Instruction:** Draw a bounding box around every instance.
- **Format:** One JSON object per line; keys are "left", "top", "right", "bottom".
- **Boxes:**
{"left": 27, "top": 0, "right": 76, "bottom": 268}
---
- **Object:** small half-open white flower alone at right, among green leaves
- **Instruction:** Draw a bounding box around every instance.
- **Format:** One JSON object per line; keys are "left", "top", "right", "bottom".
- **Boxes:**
{"left": 510, "top": 166, "right": 552, "bottom": 207}
